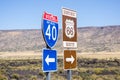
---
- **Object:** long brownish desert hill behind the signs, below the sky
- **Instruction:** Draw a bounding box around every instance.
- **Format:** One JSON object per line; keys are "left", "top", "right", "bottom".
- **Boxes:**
{"left": 0, "top": 25, "right": 120, "bottom": 52}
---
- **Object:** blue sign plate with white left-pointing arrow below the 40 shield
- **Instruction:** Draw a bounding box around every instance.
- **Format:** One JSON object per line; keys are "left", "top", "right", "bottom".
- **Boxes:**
{"left": 42, "top": 49, "right": 57, "bottom": 72}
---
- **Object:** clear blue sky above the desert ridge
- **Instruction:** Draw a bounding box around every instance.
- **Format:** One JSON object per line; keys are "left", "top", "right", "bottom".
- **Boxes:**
{"left": 0, "top": 0, "right": 120, "bottom": 30}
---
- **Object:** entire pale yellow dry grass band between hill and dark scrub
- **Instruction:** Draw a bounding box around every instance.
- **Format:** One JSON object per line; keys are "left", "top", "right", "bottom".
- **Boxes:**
{"left": 0, "top": 51, "right": 120, "bottom": 60}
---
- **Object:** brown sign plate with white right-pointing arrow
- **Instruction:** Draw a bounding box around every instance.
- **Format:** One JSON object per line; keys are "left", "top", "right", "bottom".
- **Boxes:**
{"left": 64, "top": 50, "right": 77, "bottom": 69}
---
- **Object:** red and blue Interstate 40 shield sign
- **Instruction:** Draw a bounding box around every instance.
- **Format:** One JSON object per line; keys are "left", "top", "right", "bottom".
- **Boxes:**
{"left": 42, "top": 12, "right": 58, "bottom": 48}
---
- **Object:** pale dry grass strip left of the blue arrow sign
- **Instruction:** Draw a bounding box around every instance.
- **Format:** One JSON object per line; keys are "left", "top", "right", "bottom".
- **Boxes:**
{"left": 0, "top": 51, "right": 42, "bottom": 60}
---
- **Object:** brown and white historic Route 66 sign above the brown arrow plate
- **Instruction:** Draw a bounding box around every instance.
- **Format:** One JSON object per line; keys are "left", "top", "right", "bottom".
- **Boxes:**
{"left": 62, "top": 8, "right": 77, "bottom": 48}
